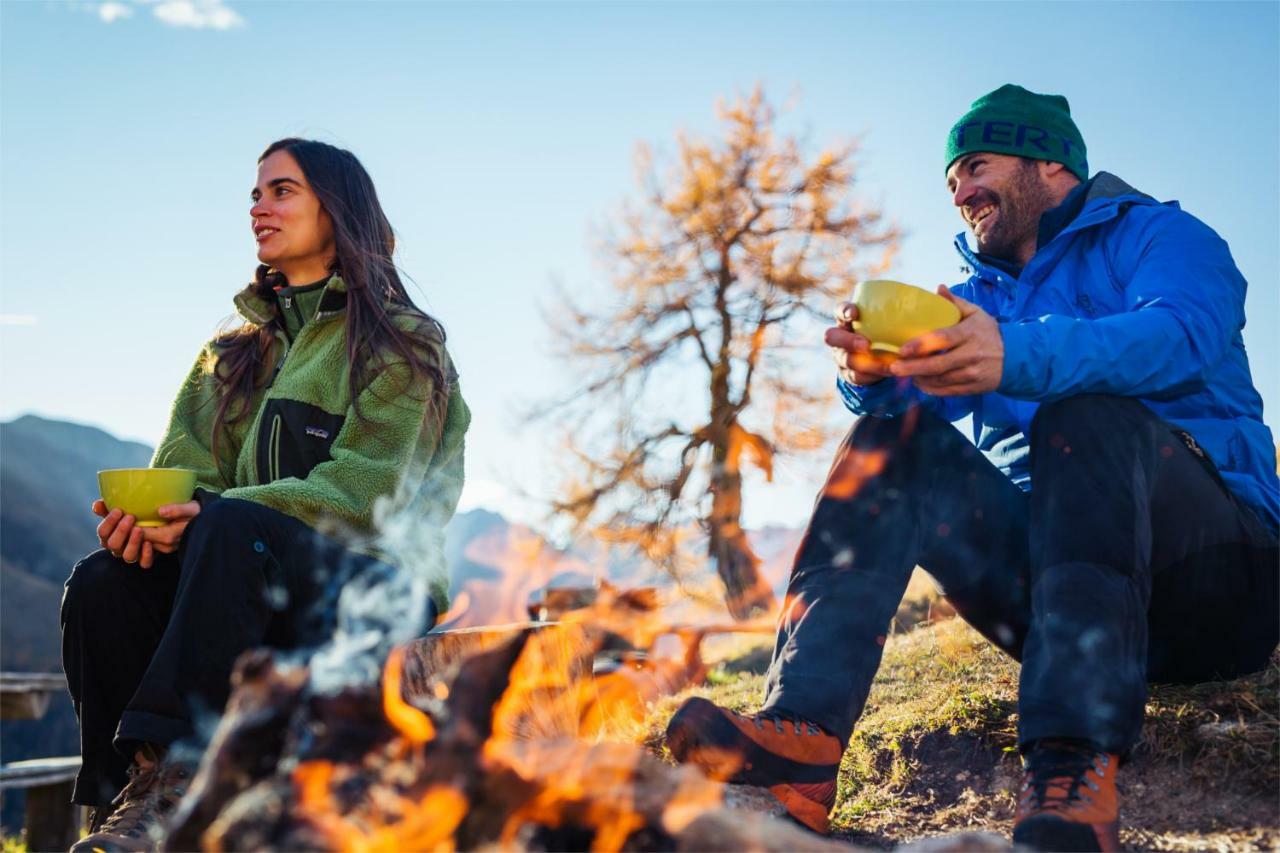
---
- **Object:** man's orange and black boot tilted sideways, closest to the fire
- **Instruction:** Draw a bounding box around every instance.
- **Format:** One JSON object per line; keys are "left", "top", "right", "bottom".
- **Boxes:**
{"left": 667, "top": 697, "right": 845, "bottom": 834}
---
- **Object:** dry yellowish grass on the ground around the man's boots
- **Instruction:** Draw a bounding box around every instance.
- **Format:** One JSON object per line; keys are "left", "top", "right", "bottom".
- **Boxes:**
{"left": 634, "top": 613, "right": 1280, "bottom": 849}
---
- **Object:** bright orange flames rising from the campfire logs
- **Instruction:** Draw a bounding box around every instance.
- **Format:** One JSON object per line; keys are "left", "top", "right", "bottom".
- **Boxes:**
{"left": 286, "top": 525, "right": 778, "bottom": 853}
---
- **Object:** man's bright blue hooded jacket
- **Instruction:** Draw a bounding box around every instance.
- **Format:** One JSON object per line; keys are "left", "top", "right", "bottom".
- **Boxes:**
{"left": 837, "top": 172, "right": 1280, "bottom": 528}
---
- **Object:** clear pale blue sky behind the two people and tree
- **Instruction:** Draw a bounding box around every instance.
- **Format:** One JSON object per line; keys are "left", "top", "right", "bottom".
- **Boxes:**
{"left": 0, "top": 0, "right": 1280, "bottom": 525}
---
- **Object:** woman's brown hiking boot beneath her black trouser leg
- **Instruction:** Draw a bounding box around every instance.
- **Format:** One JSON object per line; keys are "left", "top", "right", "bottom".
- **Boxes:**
{"left": 70, "top": 745, "right": 191, "bottom": 853}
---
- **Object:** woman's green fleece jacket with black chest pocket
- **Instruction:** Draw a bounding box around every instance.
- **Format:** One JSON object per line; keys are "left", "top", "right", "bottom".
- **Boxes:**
{"left": 151, "top": 275, "right": 471, "bottom": 612}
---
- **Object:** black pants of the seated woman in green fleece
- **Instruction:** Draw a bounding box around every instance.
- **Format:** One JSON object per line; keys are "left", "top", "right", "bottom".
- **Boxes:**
{"left": 61, "top": 500, "right": 434, "bottom": 806}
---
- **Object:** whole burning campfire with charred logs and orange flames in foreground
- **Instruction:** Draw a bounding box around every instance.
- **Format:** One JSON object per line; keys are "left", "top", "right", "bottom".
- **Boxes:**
{"left": 164, "top": 573, "right": 838, "bottom": 853}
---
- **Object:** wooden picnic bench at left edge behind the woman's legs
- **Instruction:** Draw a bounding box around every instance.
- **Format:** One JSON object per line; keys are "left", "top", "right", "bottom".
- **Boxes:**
{"left": 0, "top": 672, "right": 81, "bottom": 850}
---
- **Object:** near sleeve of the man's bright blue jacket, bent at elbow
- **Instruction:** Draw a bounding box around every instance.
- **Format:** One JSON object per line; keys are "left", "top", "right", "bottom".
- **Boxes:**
{"left": 1000, "top": 210, "right": 1245, "bottom": 402}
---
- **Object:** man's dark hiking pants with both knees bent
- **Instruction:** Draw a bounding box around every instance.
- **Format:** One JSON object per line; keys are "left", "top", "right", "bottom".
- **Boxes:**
{"left": 765, "top": 394, "right": 1280, "bottom": 753}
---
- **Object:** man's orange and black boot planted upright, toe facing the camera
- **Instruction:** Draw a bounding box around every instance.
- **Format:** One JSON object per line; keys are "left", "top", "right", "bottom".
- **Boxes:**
{"left": 1014, "top": 742, "right": 1120, "bottom": 850}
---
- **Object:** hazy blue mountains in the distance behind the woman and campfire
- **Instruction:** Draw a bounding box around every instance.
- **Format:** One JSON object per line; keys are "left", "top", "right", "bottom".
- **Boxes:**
{"left": 0, "top": 415, "right": 799, "bottom": 829}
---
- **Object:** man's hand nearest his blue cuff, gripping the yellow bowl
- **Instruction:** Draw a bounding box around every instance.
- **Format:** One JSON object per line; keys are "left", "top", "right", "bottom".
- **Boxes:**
{"left": 890, "top": 286, "right": 1005, "bottom": 397}
